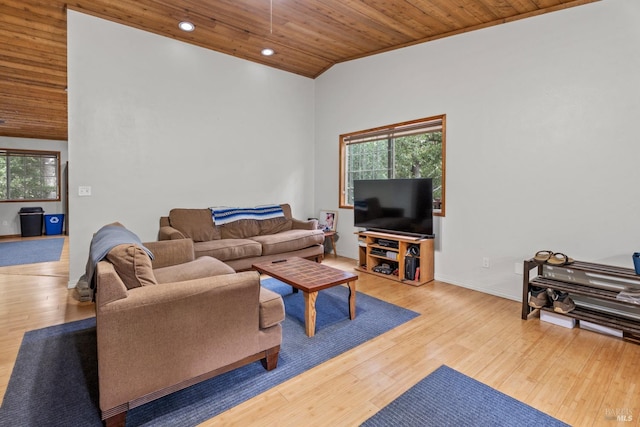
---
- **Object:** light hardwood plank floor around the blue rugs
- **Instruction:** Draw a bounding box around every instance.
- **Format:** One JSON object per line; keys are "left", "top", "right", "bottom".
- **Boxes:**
{"left": 0, "top": 242, "right": 640, "bottom": 426}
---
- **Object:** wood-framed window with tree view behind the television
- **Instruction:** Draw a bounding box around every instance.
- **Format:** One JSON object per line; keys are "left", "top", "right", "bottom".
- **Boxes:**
{"left": 340, "top": 115, "right": 445, "bottom": 216}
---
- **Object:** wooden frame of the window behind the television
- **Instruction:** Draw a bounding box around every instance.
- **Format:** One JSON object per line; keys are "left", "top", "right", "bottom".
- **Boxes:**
{"left": 338, "top": 114, "right": 447, "bottom": 217}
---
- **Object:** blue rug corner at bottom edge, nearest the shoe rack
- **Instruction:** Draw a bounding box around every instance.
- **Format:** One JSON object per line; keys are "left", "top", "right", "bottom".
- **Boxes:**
{"left": 362, "top": 365, "right": 568, "bottom": 427}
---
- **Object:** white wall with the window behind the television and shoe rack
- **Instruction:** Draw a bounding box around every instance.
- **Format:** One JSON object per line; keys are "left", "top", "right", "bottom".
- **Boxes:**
{"left": 315, "top": 0, "right": 640, "bottom": 300}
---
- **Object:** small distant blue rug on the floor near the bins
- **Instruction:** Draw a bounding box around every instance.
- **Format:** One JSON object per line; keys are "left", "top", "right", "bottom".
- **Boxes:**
{"left": 0, "top": 237, "right": 64, "bottom": 267}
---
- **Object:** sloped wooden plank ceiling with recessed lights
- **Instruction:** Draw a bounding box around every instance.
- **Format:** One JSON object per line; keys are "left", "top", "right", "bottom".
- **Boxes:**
{"left": 0, "top": 0, "right": 597, "bottom": 140}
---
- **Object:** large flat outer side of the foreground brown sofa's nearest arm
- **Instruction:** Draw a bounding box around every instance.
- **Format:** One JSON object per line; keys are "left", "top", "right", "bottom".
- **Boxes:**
{"left": 96, "top": 271, "right": 261, "bottom": 411}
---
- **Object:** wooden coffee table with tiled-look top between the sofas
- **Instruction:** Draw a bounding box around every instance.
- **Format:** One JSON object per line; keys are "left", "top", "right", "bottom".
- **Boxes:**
{"left": 253, "top": 257, "right": 358, "bottom": 337}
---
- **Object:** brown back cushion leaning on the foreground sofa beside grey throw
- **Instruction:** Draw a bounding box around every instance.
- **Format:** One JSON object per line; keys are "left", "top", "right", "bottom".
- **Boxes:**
{"left": 107, "top": 243, "right": 158, "bottom": 289}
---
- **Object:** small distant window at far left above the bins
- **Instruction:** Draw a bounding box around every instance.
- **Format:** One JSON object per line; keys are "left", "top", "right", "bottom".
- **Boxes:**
{"left": 0, "top": 148, "right": 60, "bottom": 202}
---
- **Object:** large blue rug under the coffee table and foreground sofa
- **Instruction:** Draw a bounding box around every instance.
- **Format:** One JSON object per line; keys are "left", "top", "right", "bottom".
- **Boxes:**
{"left": 0, "top": 279, "right": 418, "bottom": 427}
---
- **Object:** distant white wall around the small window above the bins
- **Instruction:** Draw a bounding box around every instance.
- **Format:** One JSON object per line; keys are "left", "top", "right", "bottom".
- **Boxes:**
{"left": 0, "top": 136, "right": 67, "bottom": 236}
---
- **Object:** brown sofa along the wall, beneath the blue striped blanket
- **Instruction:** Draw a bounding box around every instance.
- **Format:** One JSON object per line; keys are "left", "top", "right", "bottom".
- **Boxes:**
{"left": 158, "top": 204, "right": 324, "bottom": 271}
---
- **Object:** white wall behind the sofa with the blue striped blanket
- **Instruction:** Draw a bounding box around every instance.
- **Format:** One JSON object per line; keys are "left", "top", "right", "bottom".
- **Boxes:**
{"left": 68, "top": 10, "right": 314, "bottom": 283}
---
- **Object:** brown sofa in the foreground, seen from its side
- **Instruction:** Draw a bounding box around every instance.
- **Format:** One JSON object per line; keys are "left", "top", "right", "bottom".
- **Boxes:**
{"left": 95, "top": 239, "right": 284, "bottom": 426}
